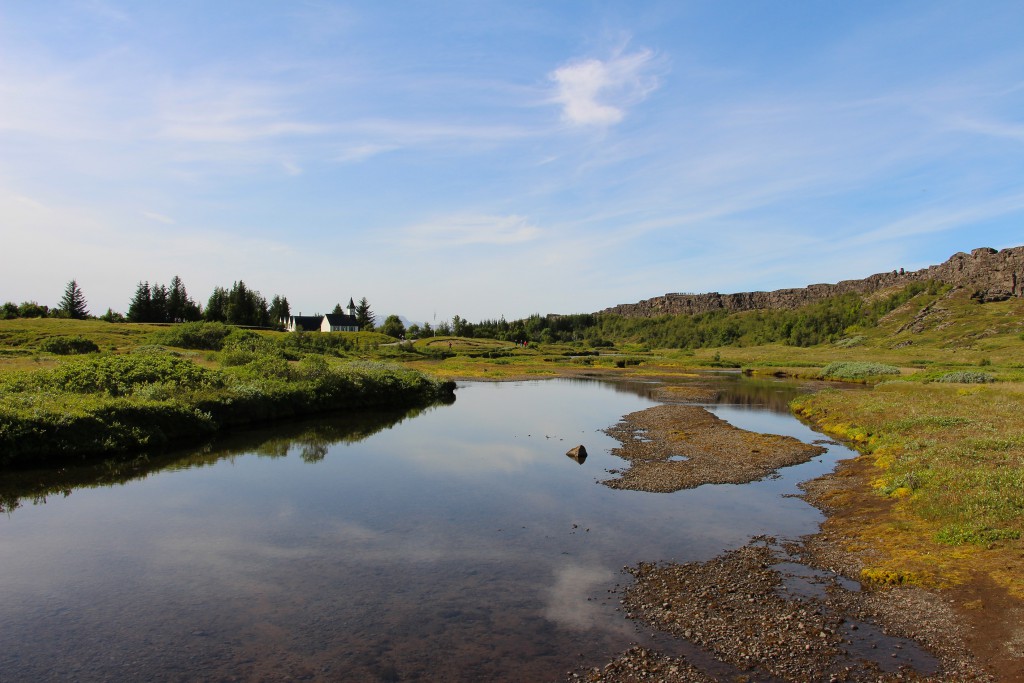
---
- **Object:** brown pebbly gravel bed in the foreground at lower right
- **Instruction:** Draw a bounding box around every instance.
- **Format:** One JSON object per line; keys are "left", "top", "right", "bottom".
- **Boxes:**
{"left": 598, "top": 539, "right": 991, "bottom": 682}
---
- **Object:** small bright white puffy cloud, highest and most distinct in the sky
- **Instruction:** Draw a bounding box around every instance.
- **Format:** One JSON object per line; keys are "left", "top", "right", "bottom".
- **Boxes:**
{"left": 549, "top": 49, "right": 658, "bottom": 126}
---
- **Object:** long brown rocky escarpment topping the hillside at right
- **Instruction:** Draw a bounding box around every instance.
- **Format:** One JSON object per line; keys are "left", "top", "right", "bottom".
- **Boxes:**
{"left": 601, "top": 247, "right": 1024, "bottom": 317}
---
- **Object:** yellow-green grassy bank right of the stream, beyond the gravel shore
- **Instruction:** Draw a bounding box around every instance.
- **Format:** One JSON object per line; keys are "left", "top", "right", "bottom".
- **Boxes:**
{"left": 793, "top": 381, "right": 1024, "bottom": 598}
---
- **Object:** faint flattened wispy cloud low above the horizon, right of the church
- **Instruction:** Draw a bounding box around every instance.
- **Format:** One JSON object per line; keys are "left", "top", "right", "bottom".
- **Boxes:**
{"left": 400, "top": 215, "right": 542, "bottom": 249}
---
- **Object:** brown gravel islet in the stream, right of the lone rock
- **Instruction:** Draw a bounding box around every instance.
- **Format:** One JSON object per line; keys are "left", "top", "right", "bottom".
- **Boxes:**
{"left": 601, "top": 404, "right": 825, "bottom": 493}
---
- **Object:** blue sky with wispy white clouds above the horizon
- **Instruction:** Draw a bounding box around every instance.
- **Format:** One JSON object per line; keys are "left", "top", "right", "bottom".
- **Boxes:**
{"left": 0, "top": 0, "right": 1024, "bottom": 322}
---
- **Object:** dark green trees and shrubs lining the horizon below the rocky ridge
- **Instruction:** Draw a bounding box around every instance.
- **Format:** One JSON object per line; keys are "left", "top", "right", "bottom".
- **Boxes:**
{"left": 0, "top": 275, "right": 949, "bottom": 349}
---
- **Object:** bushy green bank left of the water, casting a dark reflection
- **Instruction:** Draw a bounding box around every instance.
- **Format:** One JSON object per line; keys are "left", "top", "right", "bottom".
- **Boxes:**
{"left": 0, "top": 346, "right": 454, "bottom": 466}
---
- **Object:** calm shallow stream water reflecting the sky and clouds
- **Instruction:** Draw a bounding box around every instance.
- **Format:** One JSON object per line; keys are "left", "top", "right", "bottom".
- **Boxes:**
{"left": 0, "top": 376, "right": 850, "bottom": 681}
